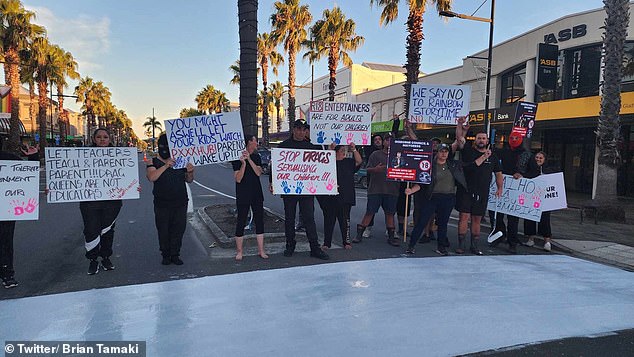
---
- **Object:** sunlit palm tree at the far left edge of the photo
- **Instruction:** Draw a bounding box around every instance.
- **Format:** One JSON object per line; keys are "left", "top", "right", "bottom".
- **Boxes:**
{"left": 0, "top": 0, "right": 44, "bottom": 153}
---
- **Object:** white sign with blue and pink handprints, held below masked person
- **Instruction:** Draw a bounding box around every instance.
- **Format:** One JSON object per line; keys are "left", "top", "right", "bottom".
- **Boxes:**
{"left": 488, "top": 174, "right": 544, "bottom": 222}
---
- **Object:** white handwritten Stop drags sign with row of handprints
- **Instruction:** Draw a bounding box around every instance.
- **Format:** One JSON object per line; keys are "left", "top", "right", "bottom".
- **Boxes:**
{"left": 271, "top": 148, "right": 339, "bottom": 195}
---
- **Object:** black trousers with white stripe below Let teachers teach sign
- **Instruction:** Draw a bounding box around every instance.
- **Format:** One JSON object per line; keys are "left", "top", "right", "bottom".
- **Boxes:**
{"left": 79, "top": 201, "right": 121, "bottom": 259}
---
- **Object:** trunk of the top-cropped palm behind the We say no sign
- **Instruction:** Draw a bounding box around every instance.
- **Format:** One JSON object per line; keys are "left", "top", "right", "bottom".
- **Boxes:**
{"left": 403, "top": 11, "right": 423, "bottom": 115}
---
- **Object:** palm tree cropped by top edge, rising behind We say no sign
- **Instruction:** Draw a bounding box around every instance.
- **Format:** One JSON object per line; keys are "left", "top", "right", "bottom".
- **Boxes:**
{"left": 370, "top": 0, "right": 453, "bottom": 113}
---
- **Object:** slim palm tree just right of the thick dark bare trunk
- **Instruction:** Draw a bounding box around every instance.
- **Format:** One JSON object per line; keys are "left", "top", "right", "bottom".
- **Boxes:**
{"left": 258, "top": 32, "right": 284, "bottom": 147}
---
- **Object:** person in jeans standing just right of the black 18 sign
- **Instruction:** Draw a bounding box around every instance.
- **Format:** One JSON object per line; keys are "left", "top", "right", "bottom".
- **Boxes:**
{"left": 405, "top": 144, "right": 467, "bottom": 255}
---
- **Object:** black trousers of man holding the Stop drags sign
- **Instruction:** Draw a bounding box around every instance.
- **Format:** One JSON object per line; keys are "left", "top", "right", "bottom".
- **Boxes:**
{"left": 282, "top": 195, "right": 319, "bottom": 251}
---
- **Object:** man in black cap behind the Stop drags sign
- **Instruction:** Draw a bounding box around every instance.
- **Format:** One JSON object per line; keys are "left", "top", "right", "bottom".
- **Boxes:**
{"left": 269, "top": 119, "right": 330, "bottom": 260}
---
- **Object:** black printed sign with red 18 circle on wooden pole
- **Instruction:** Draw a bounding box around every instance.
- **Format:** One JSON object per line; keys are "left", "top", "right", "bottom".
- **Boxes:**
{"left": 387, "top": 139, "right": 432, "bottom": 185}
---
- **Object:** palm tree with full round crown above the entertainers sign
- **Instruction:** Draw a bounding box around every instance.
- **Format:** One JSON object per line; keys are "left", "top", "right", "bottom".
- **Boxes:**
{"left": 307, "top": 6, "right": 363, "bottom": 102}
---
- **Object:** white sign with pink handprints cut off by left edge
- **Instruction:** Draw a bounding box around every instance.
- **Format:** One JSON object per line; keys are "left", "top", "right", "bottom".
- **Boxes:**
{"left": 0, "top": 160, "right": 40, "bottom": 221}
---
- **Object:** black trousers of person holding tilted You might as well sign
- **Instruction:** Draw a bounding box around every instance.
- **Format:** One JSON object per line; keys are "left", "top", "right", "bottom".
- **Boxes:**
{"left": 154, "top": 205, "right": 187, "bottom": 257}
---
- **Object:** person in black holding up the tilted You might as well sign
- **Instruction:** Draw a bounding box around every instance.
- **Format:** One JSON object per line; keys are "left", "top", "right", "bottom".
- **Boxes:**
{"left": 146, "top": 134, "right": 194, "bottom": 265}
